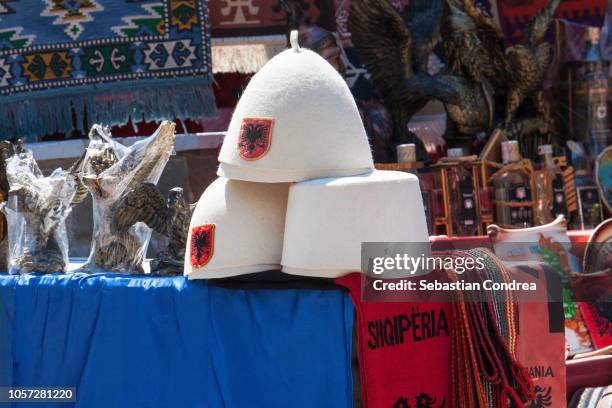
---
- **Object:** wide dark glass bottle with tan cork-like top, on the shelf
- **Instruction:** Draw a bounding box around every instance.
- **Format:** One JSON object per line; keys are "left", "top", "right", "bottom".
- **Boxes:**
{"left": 494, "top": 140, "right": 533, "bottom": 228}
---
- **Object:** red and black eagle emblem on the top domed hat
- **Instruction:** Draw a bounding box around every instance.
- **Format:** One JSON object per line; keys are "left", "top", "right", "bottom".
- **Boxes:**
{"left": 238, "top": 118, "right": 274, "bottom": 160}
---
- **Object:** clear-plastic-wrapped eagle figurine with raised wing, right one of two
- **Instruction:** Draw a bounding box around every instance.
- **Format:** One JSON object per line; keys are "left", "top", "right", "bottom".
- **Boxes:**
{"left": 83, "top": 122, "right": 174, "bottom": 273}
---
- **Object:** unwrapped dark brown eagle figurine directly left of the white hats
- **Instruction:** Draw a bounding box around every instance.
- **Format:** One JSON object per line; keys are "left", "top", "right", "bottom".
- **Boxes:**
{"left": 112, "top": 183, "right": 195, "bottom": 276}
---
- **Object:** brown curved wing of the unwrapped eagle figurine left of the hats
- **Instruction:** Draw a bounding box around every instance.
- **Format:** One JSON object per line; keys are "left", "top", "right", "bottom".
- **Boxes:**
{"left": 113, "top": 183, "right": 170, "bottom": 235}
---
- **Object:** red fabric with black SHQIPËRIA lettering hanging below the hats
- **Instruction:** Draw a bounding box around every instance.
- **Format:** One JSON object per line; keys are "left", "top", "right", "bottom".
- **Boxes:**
{"left": 336, "top": 273, "right": 451, "bottom": 408}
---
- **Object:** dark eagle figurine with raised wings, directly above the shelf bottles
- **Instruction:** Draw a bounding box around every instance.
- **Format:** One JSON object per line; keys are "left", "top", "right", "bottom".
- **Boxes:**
{"left": 439, "top": 0, "right": 560, "bottom": 150}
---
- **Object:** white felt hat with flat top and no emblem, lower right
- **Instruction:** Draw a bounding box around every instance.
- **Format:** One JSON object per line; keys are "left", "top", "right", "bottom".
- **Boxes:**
{"left": 281, "top": 170, "right": 429, "bottom": 278}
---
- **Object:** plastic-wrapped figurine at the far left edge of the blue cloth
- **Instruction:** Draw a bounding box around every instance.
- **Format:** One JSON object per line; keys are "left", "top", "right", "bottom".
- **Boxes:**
{"left": 1, "top": 152, "right": 76, "bottom": 274}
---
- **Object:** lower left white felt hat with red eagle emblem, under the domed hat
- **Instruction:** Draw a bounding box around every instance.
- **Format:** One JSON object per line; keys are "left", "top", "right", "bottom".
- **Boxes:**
{"left": 185, "top": 177, "right": 289, "bottom": 279}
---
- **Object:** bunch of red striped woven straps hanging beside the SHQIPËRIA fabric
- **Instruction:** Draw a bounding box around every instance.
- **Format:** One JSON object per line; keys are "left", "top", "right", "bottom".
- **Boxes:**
{"left": 445, "top": 249, "right": 533, "bottom": 408}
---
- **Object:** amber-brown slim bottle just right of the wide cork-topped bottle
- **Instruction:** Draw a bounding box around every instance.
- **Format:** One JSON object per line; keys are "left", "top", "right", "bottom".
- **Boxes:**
{"left": 535, "top": 144, "right": 568, "bottom": 224}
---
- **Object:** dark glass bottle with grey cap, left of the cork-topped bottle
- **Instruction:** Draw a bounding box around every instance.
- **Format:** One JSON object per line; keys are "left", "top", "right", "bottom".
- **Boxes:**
{"left": 447, "top": 147, "right": 479, "bottom": 236}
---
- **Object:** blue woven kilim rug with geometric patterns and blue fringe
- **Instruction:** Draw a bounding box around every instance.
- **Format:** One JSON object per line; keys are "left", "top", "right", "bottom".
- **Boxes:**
{"left": 0, "top": 0, "right": 216, "bottom": 140}
